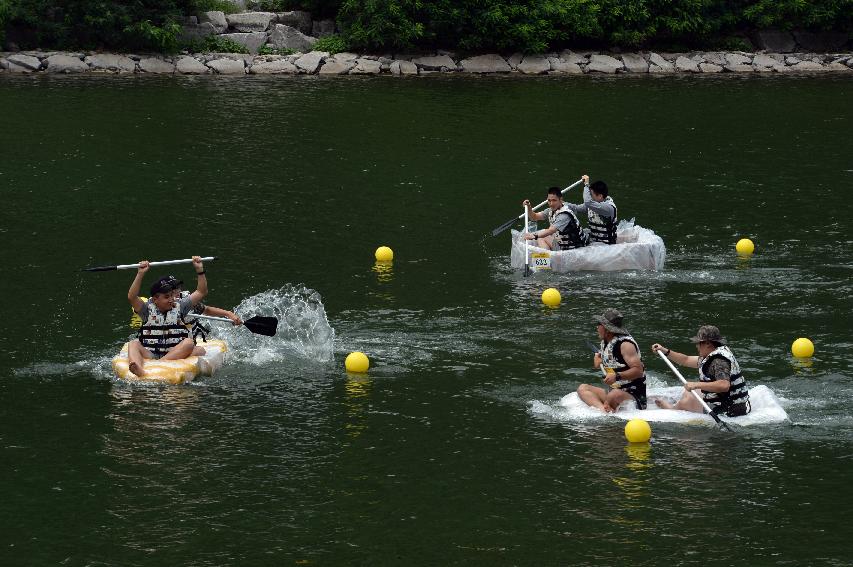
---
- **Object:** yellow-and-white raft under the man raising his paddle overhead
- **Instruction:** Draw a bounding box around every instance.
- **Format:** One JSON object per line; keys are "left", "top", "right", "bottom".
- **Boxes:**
{"left": 113, "top": 340, "right": 228, "bottom": 384}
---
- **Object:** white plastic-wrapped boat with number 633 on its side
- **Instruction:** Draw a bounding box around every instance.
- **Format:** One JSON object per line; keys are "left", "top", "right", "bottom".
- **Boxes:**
{"left": 510, "top": 220, "right": 666, "bottom": 273}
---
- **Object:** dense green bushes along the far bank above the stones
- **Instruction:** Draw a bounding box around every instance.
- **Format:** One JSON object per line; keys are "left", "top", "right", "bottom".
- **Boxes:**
{"left": 0, "top": 0, "right": 853, "bottom": 52}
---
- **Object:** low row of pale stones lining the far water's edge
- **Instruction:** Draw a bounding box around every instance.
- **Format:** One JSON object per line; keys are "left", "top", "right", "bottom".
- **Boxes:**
{"left": 0, "top": 50, "right": 853, "bottom": 76}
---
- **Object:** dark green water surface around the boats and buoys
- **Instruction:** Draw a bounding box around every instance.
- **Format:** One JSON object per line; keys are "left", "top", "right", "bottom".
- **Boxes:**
{"left": 0, "top": 76, "right": 853, "bottom": 566}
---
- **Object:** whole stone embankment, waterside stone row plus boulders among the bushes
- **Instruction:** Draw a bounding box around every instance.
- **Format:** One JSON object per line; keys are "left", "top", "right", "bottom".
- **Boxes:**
{"left": 0, "top": 9, "right": 853, "bottom": 75}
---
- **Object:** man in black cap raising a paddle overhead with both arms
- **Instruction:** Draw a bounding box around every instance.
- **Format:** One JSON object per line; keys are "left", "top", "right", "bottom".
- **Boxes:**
{"left": 127, "top": 256, "right": 207, "bottom": 377}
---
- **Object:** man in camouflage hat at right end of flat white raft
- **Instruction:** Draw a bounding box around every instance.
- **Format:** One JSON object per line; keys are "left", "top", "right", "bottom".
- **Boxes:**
{"left": 652, "top": 325, "right": 752, "bottom": 417}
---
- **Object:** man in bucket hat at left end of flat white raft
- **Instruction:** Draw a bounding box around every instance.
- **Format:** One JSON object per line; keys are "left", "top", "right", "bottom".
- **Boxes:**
{"left": 578, "top": 309, "right": 646, "bottom": 413}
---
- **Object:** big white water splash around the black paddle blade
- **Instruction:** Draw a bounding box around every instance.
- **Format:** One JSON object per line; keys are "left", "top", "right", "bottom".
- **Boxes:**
{"left": 213, "top": 284, "right": 335, "bottom": 364}
